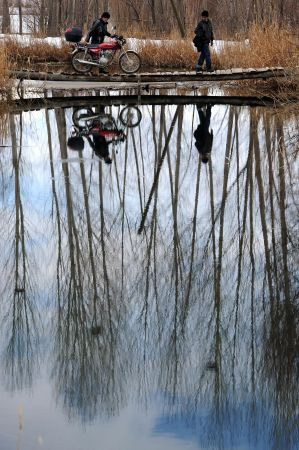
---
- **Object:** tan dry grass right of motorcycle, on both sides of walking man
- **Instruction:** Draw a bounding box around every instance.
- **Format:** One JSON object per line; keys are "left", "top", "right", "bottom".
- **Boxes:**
{"left": 138, "top": 24, "right": 299, "bottom": 70}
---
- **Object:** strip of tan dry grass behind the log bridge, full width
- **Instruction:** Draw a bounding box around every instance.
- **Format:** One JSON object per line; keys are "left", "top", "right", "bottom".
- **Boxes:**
{"left": 0, "top": 24, "right": 299, "bottom": 70}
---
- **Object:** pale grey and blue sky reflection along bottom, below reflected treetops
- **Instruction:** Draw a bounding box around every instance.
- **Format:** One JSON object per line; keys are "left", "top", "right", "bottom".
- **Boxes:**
{"left": 0, "top": 378, "right": 298, "bottom": 450}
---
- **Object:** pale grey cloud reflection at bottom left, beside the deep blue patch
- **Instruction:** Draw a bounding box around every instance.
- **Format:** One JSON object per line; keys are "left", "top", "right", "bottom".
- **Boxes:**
{"left": 0, "top": 380, "right": 202, "bottom": 450}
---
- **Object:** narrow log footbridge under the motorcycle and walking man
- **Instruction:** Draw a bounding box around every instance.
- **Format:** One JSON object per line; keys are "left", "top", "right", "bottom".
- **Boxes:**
{"left": 10, "top": 67, "right": 288, "bottom": 84}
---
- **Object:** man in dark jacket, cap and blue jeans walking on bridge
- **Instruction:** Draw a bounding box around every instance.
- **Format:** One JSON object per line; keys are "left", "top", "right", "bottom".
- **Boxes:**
{"left": 193, "top": 10, "right": 214, "bottom": 73}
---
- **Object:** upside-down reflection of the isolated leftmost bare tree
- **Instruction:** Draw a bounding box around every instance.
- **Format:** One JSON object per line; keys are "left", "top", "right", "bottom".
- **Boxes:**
{"left": 1, "top": 115, "right": 39, "bottom": 391}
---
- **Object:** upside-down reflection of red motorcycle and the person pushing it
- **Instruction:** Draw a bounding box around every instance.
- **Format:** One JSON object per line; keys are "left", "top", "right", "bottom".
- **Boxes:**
{"left": 68, "top": 106, "right": 142, "bottom": 164}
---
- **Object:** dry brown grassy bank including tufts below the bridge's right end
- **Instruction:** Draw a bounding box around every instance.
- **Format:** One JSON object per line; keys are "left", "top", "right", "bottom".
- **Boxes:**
{"left": 0, "top": 24, "right": 299, "bottom": 101}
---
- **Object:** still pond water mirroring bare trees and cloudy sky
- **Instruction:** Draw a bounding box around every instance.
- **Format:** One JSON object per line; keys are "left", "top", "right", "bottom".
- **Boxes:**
{"left": 0, "top": 101, "right": 299, "bottom": 450}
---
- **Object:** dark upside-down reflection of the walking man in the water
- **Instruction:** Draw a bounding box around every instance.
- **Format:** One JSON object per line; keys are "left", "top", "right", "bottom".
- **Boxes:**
{"left": 194, "top": 105, "right": 213, "bottom": 164}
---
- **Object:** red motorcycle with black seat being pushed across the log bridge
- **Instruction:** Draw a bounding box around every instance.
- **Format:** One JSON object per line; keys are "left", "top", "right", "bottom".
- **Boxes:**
{"left": 72, "top": 35, "right": 141, "bottom": 74}
